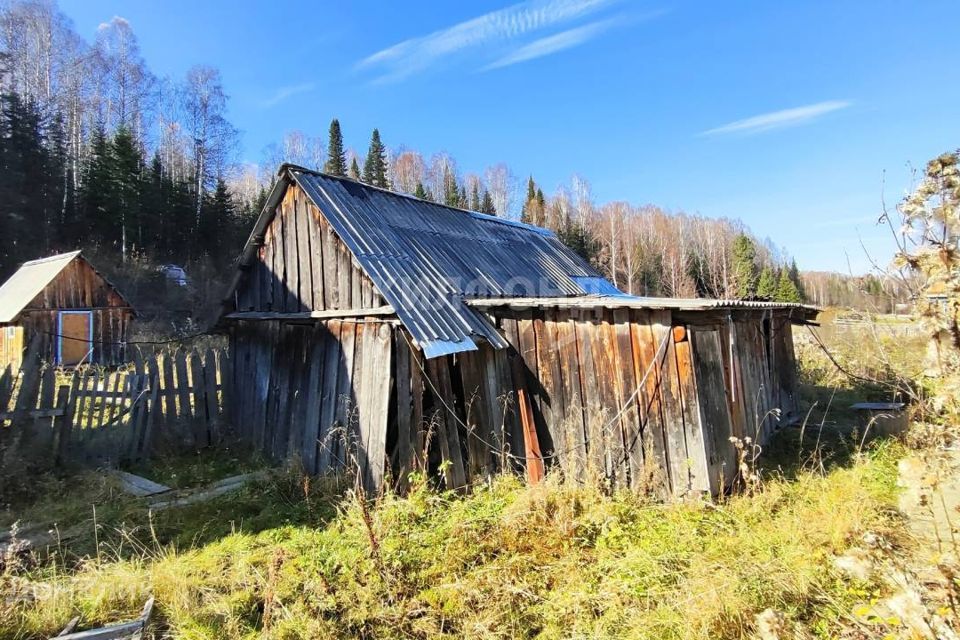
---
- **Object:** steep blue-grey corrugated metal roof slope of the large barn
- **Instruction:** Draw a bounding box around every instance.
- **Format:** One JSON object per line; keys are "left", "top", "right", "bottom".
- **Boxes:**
{"left": 289, "top": 167, "right": 600, "bottom": 357}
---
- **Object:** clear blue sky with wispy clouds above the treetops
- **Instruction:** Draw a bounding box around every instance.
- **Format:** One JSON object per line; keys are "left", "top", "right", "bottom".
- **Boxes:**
{"left": 60, "top": 0, "right": 960, "bottom": 273}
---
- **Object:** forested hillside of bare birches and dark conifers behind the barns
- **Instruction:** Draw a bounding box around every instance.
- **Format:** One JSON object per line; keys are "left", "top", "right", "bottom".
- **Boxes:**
{"left": 0, "top": 0, "right": 884, "bottom": 304}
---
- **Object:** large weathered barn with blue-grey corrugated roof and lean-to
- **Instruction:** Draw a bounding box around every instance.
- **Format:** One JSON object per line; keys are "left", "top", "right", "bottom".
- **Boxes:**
{"left": 221, "top": 165, "right": 816, "bottom": 496}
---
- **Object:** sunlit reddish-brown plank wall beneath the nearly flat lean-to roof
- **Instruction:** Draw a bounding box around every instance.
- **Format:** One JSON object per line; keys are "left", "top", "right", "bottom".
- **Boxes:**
{"left": 480, "top": 309, "right": 796, "bottom": 495}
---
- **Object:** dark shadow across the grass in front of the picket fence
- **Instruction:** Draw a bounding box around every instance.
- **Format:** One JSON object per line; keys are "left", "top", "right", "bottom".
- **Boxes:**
{"left": 0, "top": 449, "right": 350, "bottom": 566}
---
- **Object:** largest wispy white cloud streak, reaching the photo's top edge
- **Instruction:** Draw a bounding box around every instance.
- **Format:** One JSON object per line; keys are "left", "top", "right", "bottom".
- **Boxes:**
{"left": 356, "top": 0, "right": 617, "bottom": 81}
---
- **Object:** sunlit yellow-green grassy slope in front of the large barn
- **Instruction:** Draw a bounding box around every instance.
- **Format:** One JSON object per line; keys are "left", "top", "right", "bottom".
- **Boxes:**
{"left": 0, "top": 445, "right": 899, "bottom": 638}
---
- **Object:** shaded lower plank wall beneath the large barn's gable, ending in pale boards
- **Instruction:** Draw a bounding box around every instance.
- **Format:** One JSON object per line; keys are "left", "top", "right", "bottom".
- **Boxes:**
{"left": 231, "top": 318, "right": 393, "bottom": 489}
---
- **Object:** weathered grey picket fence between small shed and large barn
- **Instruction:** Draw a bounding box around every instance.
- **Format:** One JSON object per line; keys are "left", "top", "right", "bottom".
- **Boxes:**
{"left": 0, "top": 349, "right": 231, "bottom": 463}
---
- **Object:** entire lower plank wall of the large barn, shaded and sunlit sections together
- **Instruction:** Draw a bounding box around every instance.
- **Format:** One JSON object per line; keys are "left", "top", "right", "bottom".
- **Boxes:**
{"left": 225, "top": 306, "right": 795, "bottom": 496}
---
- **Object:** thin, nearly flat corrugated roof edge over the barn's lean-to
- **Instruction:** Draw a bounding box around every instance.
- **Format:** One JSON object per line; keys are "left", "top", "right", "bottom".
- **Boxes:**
{"left": 467, "top": 295, "right": 820, "bottom": 315}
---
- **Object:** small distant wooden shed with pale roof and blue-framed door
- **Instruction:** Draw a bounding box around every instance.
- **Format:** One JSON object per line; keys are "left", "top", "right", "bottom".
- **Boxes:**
{"left": 0, "top": 251, "right": 134, "bottom": 369}
